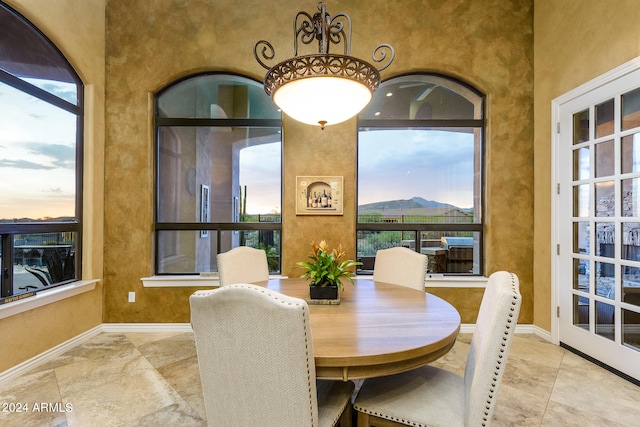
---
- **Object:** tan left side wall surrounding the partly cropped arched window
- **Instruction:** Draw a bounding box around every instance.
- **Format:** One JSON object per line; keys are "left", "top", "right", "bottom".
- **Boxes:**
{"left": 0, "top": 0, "right": 105, "bottom": 371}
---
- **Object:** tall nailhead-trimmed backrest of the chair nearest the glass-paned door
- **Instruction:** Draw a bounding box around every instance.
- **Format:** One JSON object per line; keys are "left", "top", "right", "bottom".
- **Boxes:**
{"left": 464, "top": 271, "right": 522, "bottom": 426}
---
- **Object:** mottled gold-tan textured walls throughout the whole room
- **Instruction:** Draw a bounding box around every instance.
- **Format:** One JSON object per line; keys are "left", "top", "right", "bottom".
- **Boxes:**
{"left": 7, "top": 0, "right": 640, "bottom": 362}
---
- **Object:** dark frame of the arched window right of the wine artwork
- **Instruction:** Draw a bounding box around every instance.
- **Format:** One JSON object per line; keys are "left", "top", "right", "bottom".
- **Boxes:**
{"left": 355, "top": 73, "right": 486, "bottom": 277}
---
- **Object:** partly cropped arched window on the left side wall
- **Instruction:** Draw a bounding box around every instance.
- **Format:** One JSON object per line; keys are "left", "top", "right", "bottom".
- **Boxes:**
{"left": 0, "top": 3, "right": 83, "bottom": 302}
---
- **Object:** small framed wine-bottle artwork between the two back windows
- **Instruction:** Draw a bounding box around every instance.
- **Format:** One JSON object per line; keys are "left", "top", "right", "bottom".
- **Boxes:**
{"left": 296, "top": 176, "right": 343, "bottom": 215}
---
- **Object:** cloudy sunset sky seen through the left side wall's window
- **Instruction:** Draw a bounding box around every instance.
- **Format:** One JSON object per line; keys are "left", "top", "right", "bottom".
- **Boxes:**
{"left": 0, "top": 83, "right": 76, "bottom": 219}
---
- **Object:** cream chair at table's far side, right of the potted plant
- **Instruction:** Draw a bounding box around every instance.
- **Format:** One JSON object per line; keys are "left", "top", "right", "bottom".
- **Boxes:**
{"left": 373, "top": 247, "right": 427, "bottom": 291}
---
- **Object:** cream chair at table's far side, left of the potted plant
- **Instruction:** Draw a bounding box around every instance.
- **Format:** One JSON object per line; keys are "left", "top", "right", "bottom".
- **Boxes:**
{"left": 217, "top": 246, "right": 269, "bottom": 286}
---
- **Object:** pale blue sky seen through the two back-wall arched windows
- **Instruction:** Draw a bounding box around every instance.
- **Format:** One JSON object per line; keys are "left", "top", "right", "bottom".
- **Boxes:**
{"left": 240, "top": 130, "right": 474, "bottom": 214}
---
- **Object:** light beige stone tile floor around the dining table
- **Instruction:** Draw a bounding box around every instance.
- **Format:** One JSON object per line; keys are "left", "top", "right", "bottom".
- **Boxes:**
{"left": 0, "top": 333, "right": 640, "bottom": 427}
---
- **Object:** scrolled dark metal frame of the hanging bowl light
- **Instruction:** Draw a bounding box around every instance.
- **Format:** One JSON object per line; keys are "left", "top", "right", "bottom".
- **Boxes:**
{"left": 253, "top": 2, "right": 395, "bottom": 113}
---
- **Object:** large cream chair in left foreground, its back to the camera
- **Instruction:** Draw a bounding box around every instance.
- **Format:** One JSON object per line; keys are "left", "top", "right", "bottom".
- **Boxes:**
{"left": 190, "top": 284, "right": 354, "bottom": 427}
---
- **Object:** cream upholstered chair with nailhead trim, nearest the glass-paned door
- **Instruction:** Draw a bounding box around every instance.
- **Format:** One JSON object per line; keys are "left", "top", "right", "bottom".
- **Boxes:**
{"left": 354, "top": 271, "right": 522, "bottom": 427}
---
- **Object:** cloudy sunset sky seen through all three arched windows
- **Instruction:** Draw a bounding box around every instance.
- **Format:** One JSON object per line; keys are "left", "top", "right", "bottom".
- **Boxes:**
{"left": 0, "top": 75, "right": 474, "bottom": 219}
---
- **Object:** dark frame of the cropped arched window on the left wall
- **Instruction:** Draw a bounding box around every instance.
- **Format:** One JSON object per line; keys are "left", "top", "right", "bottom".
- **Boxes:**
{"left": 0, "top": 2, "right": 84, "bottom": 304}
